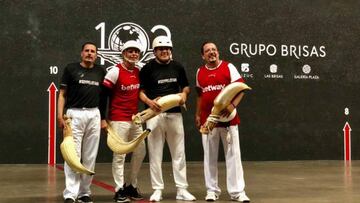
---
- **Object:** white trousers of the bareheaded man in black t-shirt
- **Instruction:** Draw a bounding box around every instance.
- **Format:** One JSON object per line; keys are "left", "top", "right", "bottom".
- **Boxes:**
{"left": 63, "top": 108, "right": 101, "bottom": 199}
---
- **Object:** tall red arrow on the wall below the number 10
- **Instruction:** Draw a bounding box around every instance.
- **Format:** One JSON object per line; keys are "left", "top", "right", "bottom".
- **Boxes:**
{"left": 47, "top": 82, "right": 58, "bottom": 166}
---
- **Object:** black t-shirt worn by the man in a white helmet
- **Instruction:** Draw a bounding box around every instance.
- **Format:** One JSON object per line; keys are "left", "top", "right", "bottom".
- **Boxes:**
{"left": 140, "top": 59, "right": 189, "bottom": 112}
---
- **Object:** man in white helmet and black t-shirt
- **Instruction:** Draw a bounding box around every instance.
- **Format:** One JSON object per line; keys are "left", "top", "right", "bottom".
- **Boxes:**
{"left": 140, "top": 36, "right": 196, "bottom": 201}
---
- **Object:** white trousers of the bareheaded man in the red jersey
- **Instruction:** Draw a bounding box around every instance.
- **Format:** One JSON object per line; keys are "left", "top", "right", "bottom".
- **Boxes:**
{"left": 202, "top": 125, "right": 245, "bottom": 196}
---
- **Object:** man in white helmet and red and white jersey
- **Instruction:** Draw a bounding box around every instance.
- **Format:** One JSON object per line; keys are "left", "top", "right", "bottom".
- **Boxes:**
{"left": 103, "top": 40, "right": 146, "bottom": 202}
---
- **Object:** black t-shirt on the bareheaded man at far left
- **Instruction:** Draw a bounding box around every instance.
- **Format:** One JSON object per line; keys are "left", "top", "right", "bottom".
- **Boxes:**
{"left": 60, "top": 63, "right": 106, "bottom": 110}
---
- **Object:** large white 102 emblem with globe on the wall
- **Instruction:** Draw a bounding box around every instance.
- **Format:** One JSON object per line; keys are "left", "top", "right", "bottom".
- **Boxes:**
{"left": 95, "top": 22, "right": 171, "bottom": 67}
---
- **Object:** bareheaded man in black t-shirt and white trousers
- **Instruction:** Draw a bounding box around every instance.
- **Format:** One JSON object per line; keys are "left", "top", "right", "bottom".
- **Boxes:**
{"left": 57, "top": 42, "right": 106, "bottom": 203}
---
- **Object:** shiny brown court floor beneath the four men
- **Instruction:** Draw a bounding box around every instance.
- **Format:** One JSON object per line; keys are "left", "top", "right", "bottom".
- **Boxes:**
{"left": 0, "top": 161, "right": 360, "bottom": 203}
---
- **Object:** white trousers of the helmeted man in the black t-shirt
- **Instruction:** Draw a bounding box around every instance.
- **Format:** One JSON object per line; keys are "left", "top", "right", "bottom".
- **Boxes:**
{"left": 146, "top": 113, "right": 188, "bottom": 190}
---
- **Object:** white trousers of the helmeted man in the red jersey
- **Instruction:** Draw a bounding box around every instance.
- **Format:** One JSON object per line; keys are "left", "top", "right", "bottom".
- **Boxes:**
{"left": 110, "top": 121, "right": 146, "bottom": 191}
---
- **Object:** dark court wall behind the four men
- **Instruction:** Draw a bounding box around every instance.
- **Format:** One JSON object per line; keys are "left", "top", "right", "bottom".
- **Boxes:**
{"left": 0, "top": 0, "right": 360, "bottom": 163}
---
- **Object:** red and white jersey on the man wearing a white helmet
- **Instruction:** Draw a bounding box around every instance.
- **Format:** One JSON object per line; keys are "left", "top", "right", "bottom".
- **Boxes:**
{"left": 103, "top": 64, "right": 140, "bottom": 121}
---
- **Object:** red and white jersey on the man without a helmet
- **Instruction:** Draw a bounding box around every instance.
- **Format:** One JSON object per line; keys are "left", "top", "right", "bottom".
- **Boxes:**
{"left": 196, "top": 61, "right": 244, "bottom": 127}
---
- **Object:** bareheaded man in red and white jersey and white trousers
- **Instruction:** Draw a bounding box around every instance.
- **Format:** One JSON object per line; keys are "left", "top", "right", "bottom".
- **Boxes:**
{"left": 195, "top": 42, "right": 250, "bottom": 202}
